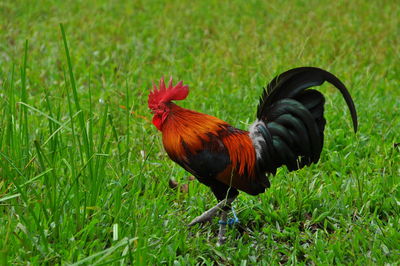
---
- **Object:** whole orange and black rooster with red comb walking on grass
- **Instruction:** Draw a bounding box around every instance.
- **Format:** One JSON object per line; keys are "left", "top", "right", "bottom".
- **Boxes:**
{"left": 148, "top": 67, "right": 357, "bottom": 244}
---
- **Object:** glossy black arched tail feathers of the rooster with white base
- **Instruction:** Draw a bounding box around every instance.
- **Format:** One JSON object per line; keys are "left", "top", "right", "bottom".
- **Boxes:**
{"left": 250, "top": 67, "right": 357, "bottom": 174}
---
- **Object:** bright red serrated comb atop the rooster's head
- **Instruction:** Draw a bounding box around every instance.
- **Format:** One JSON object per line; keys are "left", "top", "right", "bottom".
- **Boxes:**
{"left": 148, "top": 77, "right": 189, "bottom": 109}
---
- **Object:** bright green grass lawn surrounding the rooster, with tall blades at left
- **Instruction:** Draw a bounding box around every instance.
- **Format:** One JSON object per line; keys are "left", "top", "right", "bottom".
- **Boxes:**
{"left": 0, "top": 0, "right": 400, "bottom": 265}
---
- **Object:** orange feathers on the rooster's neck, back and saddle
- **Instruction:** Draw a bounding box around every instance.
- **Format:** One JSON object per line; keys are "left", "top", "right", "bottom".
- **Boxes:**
{"left": 162, "top": 103, "right": 256, "bottom": 177}
